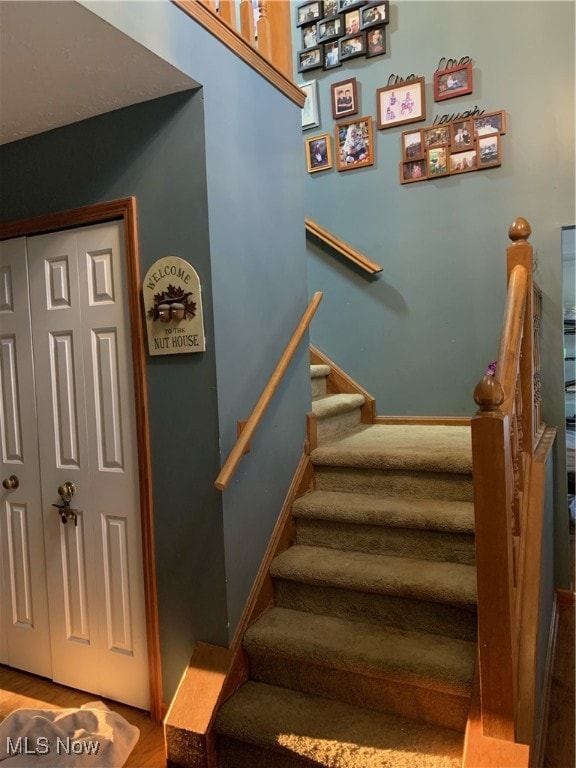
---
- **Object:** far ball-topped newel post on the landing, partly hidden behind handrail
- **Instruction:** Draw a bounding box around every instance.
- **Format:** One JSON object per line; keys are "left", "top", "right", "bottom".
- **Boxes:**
{"left": 506, "top": 216, "right": 540, "bottom": 458}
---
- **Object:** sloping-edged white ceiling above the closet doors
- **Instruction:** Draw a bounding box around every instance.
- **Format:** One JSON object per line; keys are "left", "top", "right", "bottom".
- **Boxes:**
{"left": 0, "top": 0, "right": 197, "bottom": 144}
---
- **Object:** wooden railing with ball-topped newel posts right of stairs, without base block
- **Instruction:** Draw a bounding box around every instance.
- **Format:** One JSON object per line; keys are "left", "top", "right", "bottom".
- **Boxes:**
{"left": 472, "top": 218, "right": 545, "bottom": 742}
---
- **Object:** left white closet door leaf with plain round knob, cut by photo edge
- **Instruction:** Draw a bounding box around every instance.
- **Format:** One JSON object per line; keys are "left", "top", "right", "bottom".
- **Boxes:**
{"left": 0, "top": 237, "right": 51, "bottom": 677}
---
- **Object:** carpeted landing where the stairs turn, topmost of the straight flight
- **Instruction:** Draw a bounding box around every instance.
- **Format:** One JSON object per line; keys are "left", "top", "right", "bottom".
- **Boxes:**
{"left": 311, "top": 424, "right": 472, "bottom": 474}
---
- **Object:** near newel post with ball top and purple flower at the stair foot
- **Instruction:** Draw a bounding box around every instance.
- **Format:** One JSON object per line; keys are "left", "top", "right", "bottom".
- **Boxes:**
{"left": 472, "top": 376, "right": 517, "bottom": 741}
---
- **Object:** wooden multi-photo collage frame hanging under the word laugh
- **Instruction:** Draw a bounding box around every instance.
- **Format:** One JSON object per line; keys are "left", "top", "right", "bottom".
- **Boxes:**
{"left": 399, "top": 110, "right": 506, "bottom": 184}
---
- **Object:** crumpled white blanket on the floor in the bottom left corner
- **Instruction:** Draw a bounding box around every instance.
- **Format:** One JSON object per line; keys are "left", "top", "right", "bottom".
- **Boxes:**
{"left": 0, "top": 701, "right": 140, "bottom": 768}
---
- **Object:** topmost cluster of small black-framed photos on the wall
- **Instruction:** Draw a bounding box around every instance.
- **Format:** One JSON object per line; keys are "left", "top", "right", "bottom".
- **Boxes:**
{"left": 296, "top": 0, "right": 390, "bottom": 72}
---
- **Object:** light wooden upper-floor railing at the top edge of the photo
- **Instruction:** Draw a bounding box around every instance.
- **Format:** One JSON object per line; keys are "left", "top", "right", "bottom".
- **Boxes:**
{"left": 171, "top": 0, "right": 306, "bottom": 106}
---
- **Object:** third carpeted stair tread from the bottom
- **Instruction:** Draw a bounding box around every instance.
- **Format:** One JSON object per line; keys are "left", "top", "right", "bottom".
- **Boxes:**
{"left": 270, "top": 544, "right": 476, "bottom": 606}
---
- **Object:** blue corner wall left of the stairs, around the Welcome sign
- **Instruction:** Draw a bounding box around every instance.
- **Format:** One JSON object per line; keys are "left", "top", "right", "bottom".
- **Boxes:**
{"left": 0, "top": 2, "right": 310, "bottom": 702}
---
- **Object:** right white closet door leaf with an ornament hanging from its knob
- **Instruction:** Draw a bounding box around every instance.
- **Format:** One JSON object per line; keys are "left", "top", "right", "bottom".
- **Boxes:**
{"left": 0, "top": 222, "right": 149, "bottom": 709}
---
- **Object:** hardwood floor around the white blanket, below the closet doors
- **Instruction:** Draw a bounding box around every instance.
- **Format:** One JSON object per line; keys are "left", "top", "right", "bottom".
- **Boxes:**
{"left": 0, "top": 665, "right": 166, "bottom": 768}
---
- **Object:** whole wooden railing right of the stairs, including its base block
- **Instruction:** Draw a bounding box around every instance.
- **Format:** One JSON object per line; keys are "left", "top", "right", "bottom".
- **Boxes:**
{"left": 464, "top": 218, "right": 555, "bottom": 768}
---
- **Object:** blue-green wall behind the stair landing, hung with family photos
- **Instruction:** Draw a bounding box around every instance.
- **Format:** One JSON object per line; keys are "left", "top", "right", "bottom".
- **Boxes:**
{"left": 294, "top": 1, "right": 575, "bottom": 584}
